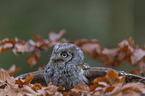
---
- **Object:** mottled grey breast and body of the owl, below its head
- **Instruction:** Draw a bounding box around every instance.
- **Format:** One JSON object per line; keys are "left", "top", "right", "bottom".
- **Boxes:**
{"left": 44, "top": 66, "right": 88, "bottom": 90}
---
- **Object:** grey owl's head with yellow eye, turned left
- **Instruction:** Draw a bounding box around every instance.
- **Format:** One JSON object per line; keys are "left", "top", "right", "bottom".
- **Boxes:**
{"left": 50, "top": 43, "right": 84, "bottom": 64}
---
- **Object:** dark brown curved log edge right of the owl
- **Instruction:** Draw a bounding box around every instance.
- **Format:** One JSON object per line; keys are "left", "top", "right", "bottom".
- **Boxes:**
{"left": 84, "top": 67, "right": 145, "bottom": 84}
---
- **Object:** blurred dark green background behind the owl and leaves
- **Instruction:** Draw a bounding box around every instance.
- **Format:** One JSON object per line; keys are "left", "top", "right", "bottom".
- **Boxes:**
{"left": 0, "top": 0, "right": 145, "bottom": 74}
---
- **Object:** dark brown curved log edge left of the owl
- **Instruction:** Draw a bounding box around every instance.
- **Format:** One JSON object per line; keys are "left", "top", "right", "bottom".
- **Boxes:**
{"left": 15, "top": 70, "right": 47, "bottom": 86}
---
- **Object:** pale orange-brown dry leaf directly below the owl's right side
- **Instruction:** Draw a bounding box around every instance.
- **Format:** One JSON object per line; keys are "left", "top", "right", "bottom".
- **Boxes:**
{"left": 71, "top": 84, "right": 89, "bottom": 93}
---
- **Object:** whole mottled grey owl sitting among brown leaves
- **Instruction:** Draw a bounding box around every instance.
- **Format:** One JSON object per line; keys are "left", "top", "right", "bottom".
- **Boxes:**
{"left": 44, "top": 43, "right": 88, "bottom": 90}
